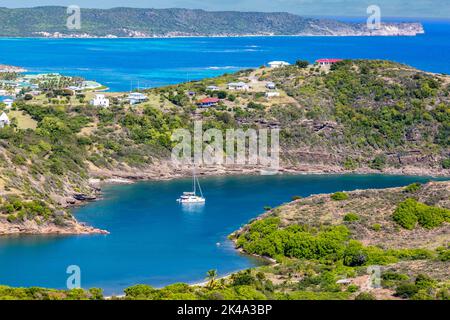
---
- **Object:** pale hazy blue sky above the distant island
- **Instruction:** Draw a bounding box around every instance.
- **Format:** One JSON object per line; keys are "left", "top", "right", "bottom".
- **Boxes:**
{"left": 0, "top": 0, "right": 450, "bottom": 19}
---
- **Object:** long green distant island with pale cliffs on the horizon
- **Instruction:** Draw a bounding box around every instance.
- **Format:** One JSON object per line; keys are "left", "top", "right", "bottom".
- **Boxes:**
{"left": 0, "top": 6, "right": 425, "bottom": 38}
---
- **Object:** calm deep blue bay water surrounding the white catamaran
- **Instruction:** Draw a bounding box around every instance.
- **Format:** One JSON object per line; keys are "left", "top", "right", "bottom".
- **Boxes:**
{"left": 0, "top": 175, "right": 444, "bottom": 294}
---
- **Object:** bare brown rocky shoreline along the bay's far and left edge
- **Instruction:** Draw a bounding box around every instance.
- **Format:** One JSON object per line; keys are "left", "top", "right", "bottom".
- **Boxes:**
{"left": 0, "top": 163, "right": 442, "bottom": 236}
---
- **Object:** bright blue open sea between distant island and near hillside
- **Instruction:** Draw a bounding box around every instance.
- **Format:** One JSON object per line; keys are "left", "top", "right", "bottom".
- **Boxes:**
{"left": 0, "top": 21, "right": 450, "bottom": 91}
